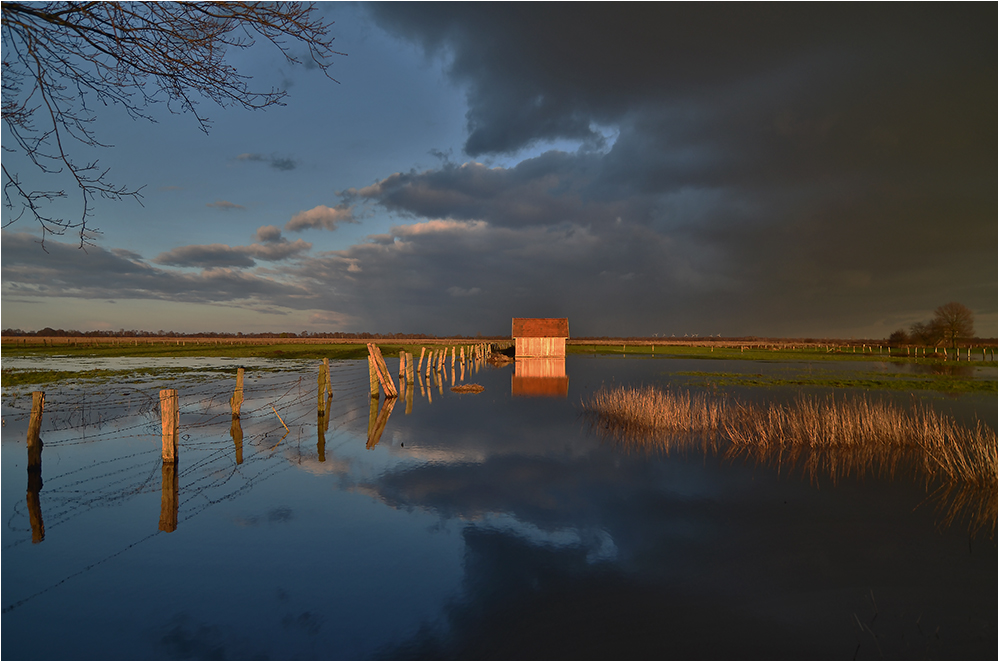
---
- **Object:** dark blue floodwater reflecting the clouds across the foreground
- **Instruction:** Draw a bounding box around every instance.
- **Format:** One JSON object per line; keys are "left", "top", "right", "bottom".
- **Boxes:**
{"left": 0, "top": 356, "right": 997, "bottom": 660}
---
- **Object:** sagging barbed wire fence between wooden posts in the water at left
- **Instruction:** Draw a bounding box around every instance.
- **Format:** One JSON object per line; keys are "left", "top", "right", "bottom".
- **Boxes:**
{"left": 3, "top": 362, "right": 369, "bottom": 550}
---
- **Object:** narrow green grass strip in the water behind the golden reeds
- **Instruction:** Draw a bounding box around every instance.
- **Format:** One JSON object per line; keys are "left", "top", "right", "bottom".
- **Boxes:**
{"left": 672, "top": 371, "right": 997, "bottom": 394}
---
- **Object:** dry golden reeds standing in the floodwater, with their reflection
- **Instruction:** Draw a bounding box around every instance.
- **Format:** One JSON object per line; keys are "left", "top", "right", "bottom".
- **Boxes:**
{"left": 583, "top": 386, "right": 997, "bottom": 536}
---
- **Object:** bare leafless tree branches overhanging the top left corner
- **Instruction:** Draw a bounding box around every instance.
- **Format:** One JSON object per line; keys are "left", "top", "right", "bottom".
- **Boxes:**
{"left": 0, "top": 2, "right": 340, "bottom": 247}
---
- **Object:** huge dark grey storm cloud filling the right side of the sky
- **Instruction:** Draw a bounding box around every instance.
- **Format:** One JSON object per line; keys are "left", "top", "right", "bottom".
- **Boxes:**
{"left": 349, "top": 3, "right": 997, "bottom": 335}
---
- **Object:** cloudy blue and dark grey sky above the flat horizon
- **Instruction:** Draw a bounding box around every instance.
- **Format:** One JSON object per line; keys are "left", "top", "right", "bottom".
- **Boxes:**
{"left": 0, "top": 3, "right": 998, "bottom": 338}
